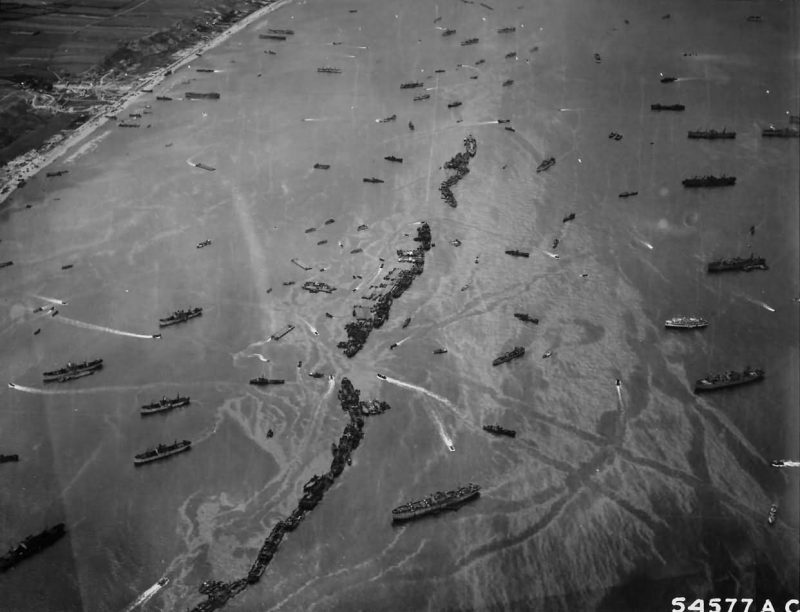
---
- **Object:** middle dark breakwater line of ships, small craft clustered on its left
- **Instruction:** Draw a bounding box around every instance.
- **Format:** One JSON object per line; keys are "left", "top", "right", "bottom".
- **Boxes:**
{"left": 336, "top": 222, "right": 431, "bottom": 357}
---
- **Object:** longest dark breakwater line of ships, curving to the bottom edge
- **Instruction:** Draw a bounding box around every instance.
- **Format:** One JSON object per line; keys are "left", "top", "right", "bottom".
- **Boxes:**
{"left": 186, "top": 378, "right": 390, "bottom": 612}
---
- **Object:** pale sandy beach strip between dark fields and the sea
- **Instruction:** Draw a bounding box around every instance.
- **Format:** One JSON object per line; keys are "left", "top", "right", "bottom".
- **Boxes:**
{"left": 0, "top": 0, "right": 293, "bottom": 206}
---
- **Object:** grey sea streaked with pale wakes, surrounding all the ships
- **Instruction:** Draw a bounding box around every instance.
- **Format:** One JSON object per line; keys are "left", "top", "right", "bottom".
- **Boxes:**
{"left": 0, "top": 0, "right": 800, "bottom": 611}
